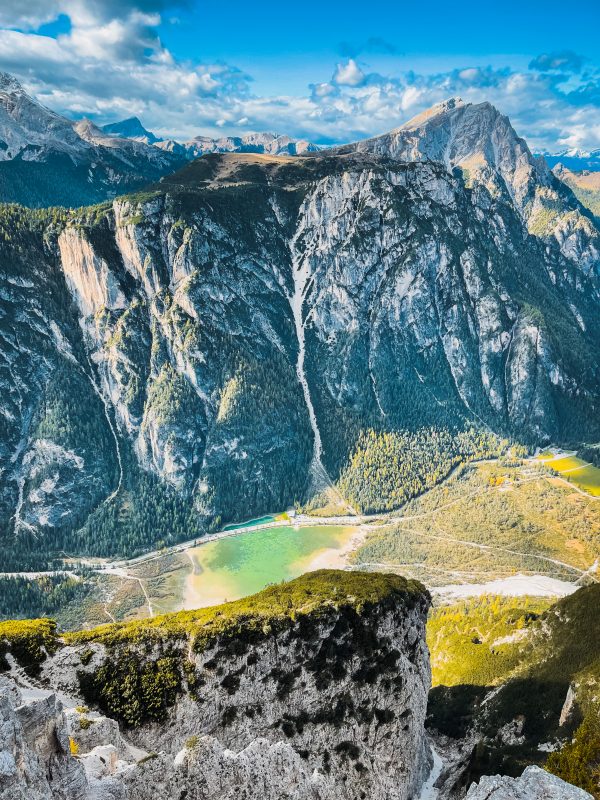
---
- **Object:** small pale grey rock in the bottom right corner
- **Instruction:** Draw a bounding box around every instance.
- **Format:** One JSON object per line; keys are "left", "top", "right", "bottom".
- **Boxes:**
{"left": 467, "top": 767, "right": 592, "bottom": 800}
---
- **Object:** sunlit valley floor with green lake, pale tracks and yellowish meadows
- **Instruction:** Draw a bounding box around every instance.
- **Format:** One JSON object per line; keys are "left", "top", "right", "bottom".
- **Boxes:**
{"left": 2, "top": 451, "right": 600, "bottom": 628}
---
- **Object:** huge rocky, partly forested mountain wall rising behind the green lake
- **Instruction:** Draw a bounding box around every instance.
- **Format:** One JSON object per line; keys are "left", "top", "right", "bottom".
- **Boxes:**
{"left": 0, "top": 81, "right": 600, "bottom": 564}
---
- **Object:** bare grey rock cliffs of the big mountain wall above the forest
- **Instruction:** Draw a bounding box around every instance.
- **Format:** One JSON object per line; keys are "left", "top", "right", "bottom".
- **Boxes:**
{"left": 50, "top": 152, "right": 597, "bottom": 487}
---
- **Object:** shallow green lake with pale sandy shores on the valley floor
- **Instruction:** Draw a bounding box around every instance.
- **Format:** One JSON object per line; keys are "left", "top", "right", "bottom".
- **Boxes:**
{"left": 185, "top": 525, "right": 356, "bottom": 608}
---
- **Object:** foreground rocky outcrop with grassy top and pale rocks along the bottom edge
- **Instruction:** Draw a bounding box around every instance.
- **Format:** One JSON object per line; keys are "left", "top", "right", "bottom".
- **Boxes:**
{"left": 0, "top": 571, "right": 593, "bottom": 800}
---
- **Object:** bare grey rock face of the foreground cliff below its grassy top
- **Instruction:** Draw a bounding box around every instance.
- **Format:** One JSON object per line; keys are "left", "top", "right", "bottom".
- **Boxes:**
{"left": 119, "top": 592, "right": 430, "bottom": 800}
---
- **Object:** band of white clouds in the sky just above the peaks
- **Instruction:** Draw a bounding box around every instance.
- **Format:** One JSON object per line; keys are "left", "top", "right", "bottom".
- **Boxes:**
{"left": 0, "top": 0, "right": 600, "bottom": 150}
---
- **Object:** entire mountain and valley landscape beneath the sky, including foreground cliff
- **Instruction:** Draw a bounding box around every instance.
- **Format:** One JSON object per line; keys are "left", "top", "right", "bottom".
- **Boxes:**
{"left": 0, "top": 67, "right": 600, "bottom": 800}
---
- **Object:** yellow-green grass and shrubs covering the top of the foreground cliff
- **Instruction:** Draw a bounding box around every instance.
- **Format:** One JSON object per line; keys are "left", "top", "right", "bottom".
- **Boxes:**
{"left": 65, "top": 570, "right": 428, "bottom": 727}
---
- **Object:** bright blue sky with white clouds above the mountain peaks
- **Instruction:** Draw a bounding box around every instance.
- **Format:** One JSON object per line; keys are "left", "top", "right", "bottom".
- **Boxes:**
{"left": 0, "top": 0, "right": 600, "bottom": 150}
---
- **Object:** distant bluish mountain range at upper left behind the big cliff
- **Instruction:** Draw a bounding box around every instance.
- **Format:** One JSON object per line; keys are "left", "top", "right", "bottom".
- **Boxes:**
{"left": 0, "top": 73, "right": 317, "bottom": 207}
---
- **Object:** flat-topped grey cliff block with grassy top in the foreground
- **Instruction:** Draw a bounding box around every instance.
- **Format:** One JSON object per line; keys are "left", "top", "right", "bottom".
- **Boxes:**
{"left": 0, "top": 571, "right": 430, "bottom": 800}
